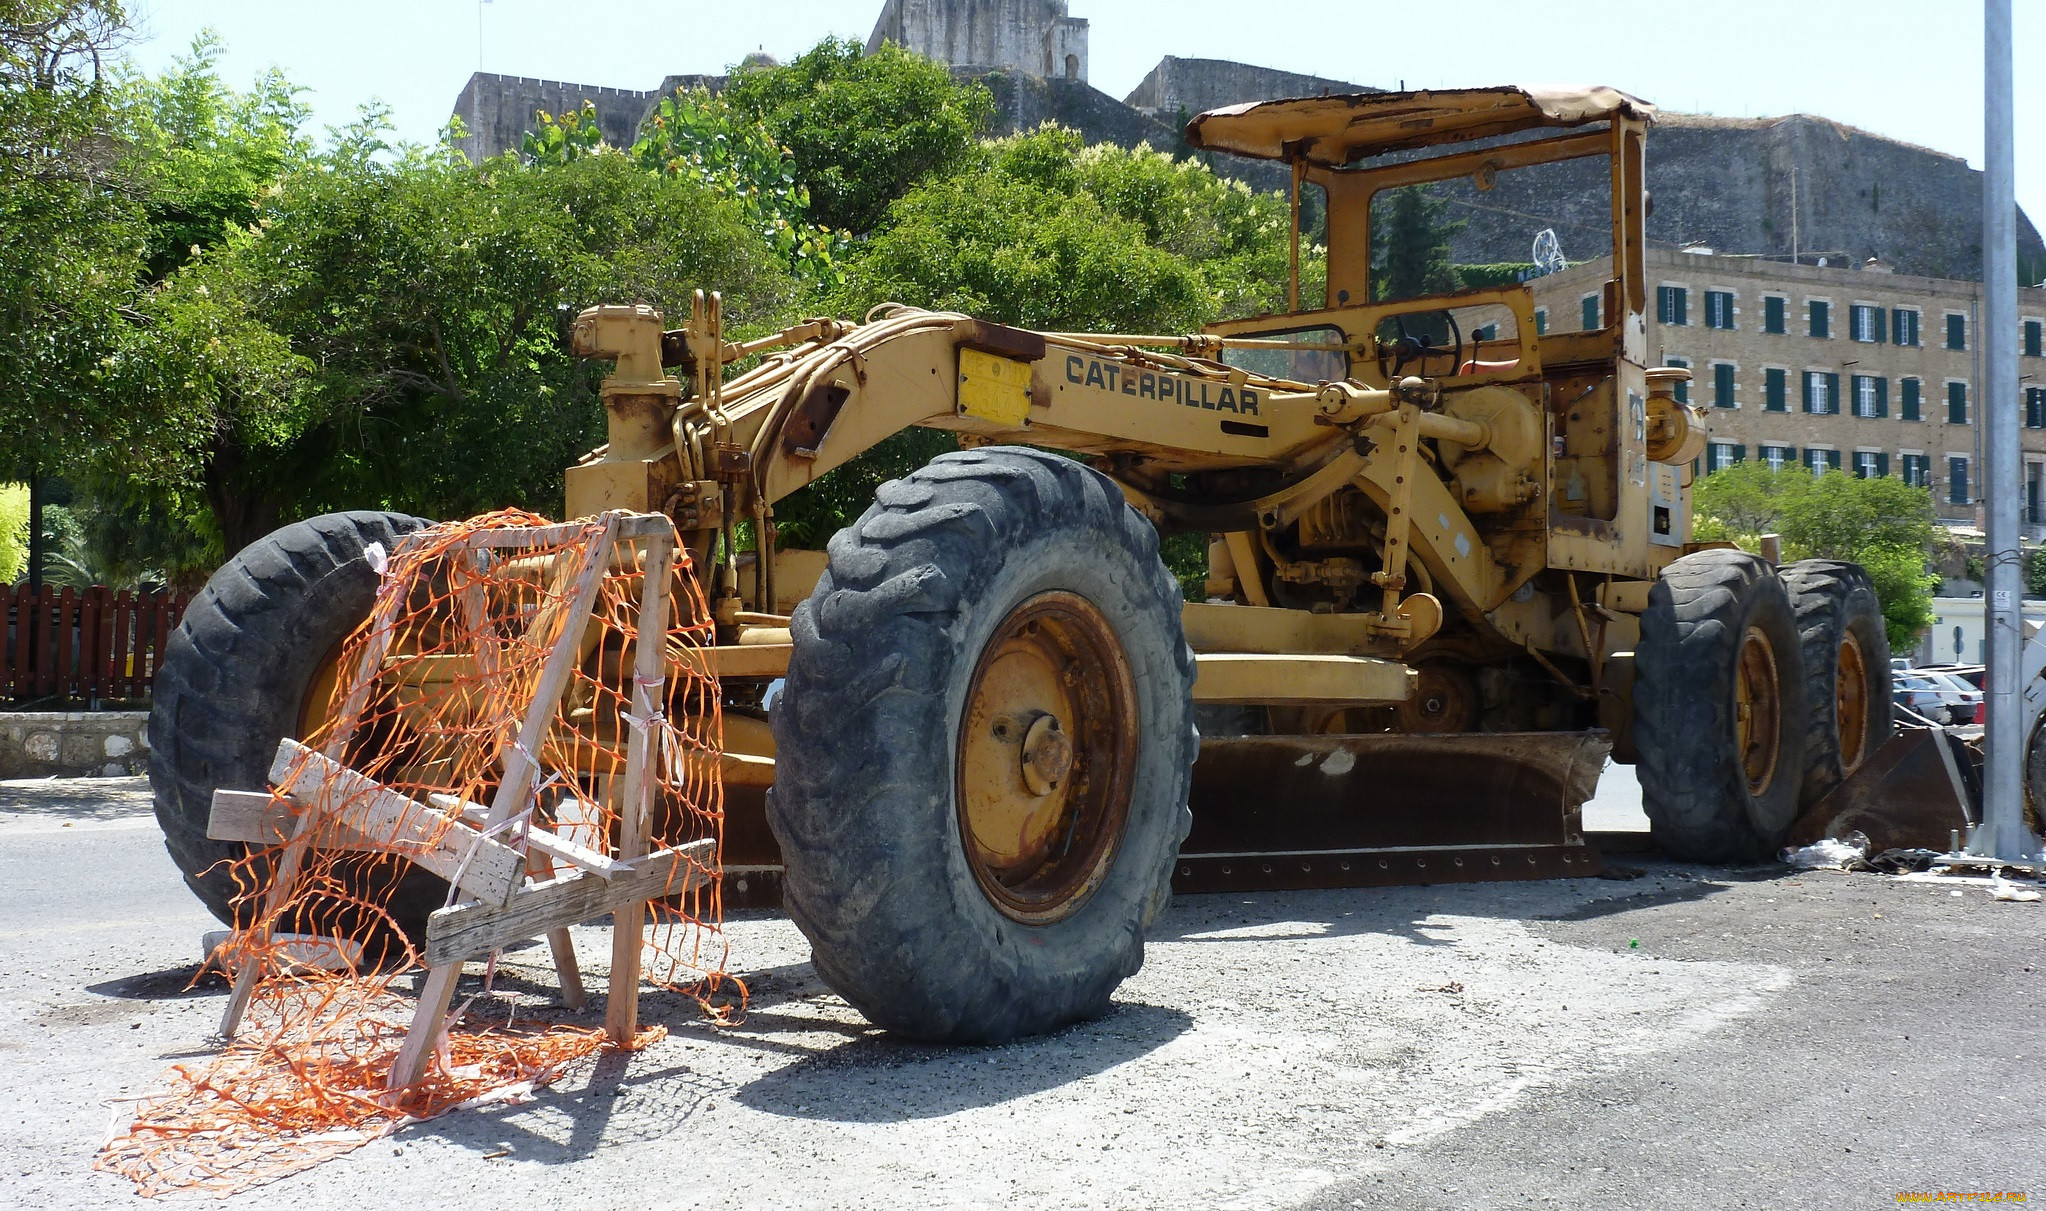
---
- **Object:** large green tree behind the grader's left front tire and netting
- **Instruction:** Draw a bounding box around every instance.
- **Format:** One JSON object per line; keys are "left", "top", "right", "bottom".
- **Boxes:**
{"left": 103, "top": 125, "right": 794, "bottom": 558}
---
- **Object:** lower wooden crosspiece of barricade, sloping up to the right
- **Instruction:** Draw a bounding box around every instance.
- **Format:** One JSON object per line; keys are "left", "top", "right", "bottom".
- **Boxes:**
{"left": 426, "top": 837, "right": 718, "bottom": 966}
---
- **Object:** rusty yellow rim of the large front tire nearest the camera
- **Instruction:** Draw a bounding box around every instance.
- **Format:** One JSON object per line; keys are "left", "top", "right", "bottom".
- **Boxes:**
{"left": 953, "top": 591, "right": 1138, "bottom": 925}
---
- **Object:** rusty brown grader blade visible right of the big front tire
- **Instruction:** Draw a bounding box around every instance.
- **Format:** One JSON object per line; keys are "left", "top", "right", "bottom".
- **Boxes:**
{"left": 1172, "top": 732, "right": 1612, "bottom": 892}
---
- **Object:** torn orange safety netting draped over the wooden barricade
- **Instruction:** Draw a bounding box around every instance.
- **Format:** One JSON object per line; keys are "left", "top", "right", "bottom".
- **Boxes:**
{"left": 96, "top": 511, "right": 745, "bottom": 1195}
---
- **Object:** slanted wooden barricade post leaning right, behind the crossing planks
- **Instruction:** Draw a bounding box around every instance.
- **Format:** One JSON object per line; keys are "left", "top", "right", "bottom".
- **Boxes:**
{"left": 387, "top": 515, "right": 618, "bottom": 1090}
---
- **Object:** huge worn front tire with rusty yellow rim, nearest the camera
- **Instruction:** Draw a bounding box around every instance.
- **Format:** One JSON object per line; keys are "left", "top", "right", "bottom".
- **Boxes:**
{"left": 767, "top": 446, "right": 1199, "bottom": 1043}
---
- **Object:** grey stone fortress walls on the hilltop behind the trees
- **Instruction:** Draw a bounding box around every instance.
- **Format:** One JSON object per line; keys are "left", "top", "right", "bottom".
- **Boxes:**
{"left": 454, "top": 0, "right": 2046, "bottom": 280}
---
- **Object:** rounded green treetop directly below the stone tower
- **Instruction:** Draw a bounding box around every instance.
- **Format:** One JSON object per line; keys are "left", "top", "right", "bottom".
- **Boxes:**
{"left": 724, "top": 39, "right": 994, "bottom": 235}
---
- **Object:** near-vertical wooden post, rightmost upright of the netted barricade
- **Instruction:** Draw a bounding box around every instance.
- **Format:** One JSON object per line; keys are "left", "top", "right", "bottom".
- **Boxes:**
{"left": 604, "top": 528, "right": 675, "bottom": 1047}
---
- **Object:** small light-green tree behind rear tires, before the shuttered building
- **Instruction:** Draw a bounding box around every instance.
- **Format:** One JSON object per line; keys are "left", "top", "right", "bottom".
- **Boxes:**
{"left": 1692, "top": 462, "right": 1940, "bottom": 648}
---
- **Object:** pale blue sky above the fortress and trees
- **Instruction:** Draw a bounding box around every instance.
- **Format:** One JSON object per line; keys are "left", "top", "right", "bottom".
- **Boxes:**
{"left": 131, "top": 0, "right": 2046, "bottom": 236}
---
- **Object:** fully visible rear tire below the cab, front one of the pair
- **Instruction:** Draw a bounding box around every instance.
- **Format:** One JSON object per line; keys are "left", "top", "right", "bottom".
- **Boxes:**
{"left": 1635, "top": 550, "right": 1809, "bottom": 861}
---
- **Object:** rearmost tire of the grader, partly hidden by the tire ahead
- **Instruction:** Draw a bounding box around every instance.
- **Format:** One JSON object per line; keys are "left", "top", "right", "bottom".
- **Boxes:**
{"left": 1778, "top": 558, "right": 1895, "bottom": 808}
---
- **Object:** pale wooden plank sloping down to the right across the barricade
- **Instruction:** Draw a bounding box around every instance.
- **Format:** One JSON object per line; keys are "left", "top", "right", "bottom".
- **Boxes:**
{"left": 265, "top": 738, "right": 526, "bottom": 900}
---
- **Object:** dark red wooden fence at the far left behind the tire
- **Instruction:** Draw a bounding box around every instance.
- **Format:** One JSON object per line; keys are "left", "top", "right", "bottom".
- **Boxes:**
{"left": 0, "top": 585, "right": 190, "bottom": 706}
